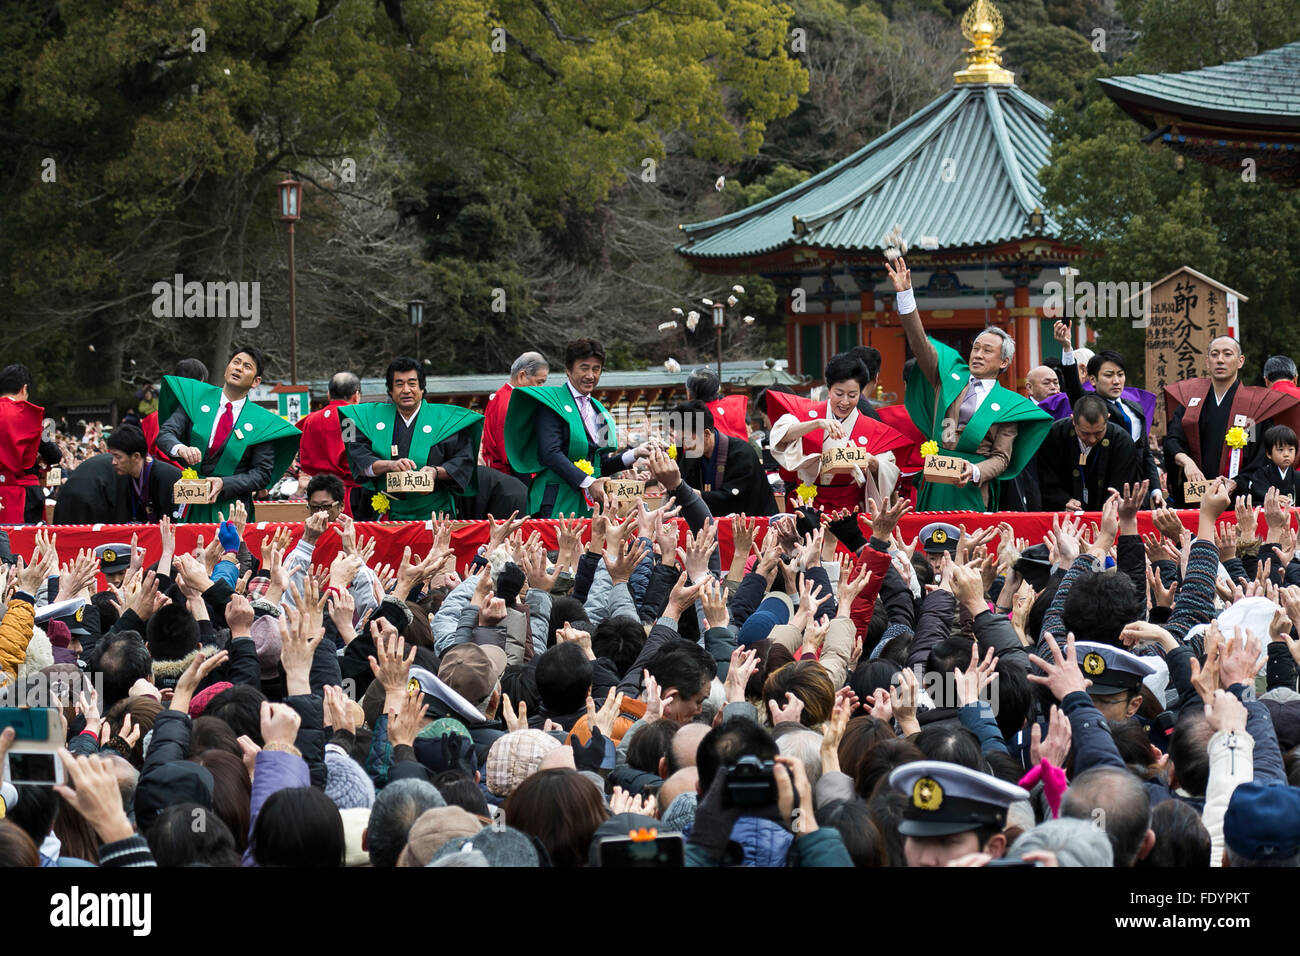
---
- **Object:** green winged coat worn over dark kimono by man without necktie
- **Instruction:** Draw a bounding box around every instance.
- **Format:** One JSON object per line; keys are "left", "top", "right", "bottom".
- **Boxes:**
{"left": 338, "top": 401, "right": 484, "bottom": 522}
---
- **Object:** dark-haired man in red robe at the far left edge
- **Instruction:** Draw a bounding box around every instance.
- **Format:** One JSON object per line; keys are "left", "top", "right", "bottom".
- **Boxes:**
{"left": 0, "top": 365, "right": 62, "bottom": 524}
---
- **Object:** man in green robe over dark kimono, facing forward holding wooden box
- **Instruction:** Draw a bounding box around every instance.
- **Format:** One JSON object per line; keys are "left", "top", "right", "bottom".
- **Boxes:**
{"left": 338, "top": 356, "right": 484, "bottom": 522}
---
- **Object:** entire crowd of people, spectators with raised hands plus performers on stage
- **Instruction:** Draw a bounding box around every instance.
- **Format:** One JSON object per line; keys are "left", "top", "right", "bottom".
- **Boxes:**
{"left": 0, "top": 252, "right": 1300, "bottom": 868}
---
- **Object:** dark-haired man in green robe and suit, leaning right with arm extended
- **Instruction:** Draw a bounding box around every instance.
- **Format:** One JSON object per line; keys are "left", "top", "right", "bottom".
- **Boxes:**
{"left": 506, "top": 338, "right": 650, "bottom": 518}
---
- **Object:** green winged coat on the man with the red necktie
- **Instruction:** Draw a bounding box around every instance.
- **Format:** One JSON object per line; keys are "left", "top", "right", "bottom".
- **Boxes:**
{"left": 159, "top": 375, "right": 302, "bottom": 524}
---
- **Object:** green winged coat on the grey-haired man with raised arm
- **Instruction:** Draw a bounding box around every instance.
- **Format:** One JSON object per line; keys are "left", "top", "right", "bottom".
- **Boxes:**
{"left": 904, "top": 339, "right": 1052, "bottom": 511}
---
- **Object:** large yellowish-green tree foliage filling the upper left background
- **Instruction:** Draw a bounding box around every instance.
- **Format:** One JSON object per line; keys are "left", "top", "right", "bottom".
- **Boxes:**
{"left": 0, "top": 0, "right": 807, "bottom": 389}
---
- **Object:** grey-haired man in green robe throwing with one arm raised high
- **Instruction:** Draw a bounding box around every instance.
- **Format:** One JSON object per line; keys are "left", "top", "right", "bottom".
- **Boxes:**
{"left": 888, "top": 258, "right": 1052, "bottom": 511}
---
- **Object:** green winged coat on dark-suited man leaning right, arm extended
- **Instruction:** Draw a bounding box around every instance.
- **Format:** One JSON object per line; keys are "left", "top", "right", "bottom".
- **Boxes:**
{"left": 506, "top": 382, "right": 619, "bottom": 518}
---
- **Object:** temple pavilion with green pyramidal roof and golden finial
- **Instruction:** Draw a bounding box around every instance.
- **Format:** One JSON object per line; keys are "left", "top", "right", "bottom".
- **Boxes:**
{"left": 677, "top": 0, "right": 1087, "bottom": 401}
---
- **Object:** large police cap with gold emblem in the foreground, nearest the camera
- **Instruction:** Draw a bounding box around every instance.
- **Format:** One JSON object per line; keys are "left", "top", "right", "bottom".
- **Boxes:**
{"left": 889, "top": 760, "right": 1030, "bottom": 836}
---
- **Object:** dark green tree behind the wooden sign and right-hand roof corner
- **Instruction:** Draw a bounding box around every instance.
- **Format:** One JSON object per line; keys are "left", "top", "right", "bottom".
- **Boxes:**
{"left": 1039, "top": 0, "right": 1300, "bottom": 381}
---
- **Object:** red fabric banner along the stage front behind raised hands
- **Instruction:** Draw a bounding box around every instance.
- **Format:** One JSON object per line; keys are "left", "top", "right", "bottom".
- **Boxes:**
{"left": 5, "top": 511, "right": 1248, "bottom": 570}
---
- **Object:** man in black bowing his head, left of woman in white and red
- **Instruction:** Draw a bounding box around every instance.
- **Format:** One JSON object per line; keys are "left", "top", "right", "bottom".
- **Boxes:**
{"left": 671, "top": 402, "right": 776, "bottom": 518}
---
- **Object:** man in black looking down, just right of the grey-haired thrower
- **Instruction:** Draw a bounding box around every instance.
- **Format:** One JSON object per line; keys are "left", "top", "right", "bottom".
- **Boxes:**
{"left": 1037, "top": 395, "right": 1143, "bottom": 511}
